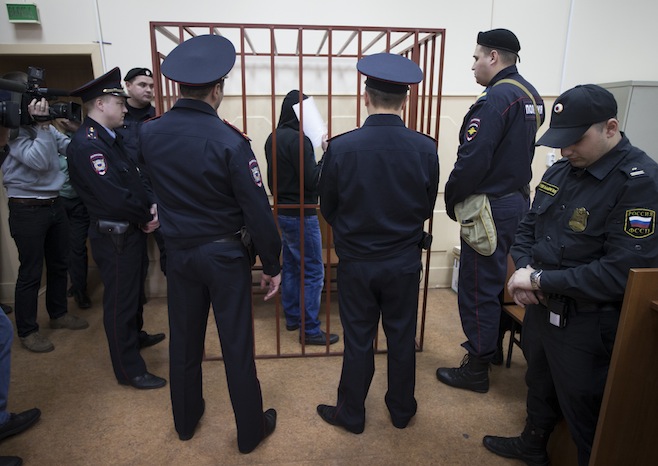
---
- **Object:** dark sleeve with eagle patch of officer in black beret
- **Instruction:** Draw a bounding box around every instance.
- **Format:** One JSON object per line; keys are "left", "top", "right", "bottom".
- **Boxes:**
{"left": 445, "top": 101, "right": 504, "bottom": 220}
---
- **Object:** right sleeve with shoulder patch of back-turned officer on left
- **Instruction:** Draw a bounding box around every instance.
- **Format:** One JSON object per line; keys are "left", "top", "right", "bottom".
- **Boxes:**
{"left": 229, "top": 140, "right": 281, "bottom": 276}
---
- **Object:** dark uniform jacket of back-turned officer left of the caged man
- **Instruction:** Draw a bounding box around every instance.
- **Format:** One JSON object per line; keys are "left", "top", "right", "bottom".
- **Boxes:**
{"left": 140, "top": 99, "right": 281, "bottom": 275}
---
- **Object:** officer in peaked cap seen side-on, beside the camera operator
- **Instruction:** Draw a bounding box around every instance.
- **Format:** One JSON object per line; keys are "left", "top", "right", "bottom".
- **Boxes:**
{"left": 67, "top": 68, "right": 166, "bottom": 389}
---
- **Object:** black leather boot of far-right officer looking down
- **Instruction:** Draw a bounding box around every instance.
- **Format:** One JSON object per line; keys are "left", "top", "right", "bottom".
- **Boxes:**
{"left": 482, "top": 424, "right": 550, "bottom": 466}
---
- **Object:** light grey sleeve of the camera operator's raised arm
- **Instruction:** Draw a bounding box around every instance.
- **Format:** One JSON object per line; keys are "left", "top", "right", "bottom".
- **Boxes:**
{"left": 9, "top": 127, "right": 60, "bottom": 172}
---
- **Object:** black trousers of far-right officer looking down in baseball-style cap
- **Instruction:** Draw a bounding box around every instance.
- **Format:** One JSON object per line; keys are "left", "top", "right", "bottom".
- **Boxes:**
{"left": 522, "top": 305, "right": 619, "bottom": 466}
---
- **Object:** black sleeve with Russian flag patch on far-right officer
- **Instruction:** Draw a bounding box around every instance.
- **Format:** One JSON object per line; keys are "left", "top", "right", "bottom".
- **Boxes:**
{"left": 541, "top": 176, "right": 658, "bottom": 301}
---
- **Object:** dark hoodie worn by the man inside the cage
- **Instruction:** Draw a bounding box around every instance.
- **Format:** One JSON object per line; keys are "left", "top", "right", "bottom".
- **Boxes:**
{"left": 265, "top": 91, "right": 322, "bottom": 217}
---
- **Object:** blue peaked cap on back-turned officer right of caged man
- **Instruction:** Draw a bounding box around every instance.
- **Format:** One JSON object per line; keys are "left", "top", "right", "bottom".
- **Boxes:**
{"left": 356, "top": 53, "right": 423, "bottom": 94}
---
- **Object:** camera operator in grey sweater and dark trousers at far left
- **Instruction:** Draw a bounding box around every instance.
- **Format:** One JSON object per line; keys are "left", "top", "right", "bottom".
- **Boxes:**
{"left": 2, "top": 72, "right": 89, "bottom": 353}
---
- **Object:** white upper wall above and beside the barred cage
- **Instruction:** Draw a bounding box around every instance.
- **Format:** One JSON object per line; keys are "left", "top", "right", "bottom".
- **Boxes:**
{"left": 0, "top": 0, "right": 658, "bottom": 96}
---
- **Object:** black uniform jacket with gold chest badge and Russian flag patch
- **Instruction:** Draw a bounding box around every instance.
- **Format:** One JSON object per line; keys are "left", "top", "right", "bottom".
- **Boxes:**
{"left": 510, "top": 136, "right": 658, "bottom": 307}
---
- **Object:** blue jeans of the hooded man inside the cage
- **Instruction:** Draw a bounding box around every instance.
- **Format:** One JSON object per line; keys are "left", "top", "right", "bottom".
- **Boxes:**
{"left": 278, "top": 215, "right": 324, "bottom": 336}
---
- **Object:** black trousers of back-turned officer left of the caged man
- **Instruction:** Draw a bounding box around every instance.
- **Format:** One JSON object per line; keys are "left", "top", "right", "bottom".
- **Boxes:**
{"left": 167, "top": 242, "right": 265, "bottom": 450}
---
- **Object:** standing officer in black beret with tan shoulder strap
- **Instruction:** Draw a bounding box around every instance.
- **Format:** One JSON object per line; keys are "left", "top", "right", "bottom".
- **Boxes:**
{"left": 436, "top": 29, "right": 544, "bottom": 393}
